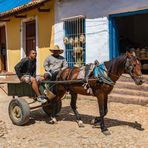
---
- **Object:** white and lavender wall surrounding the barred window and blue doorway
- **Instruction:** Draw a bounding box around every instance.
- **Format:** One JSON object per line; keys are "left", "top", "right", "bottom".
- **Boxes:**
{"left": 55, "top": 0, "right": 148, "bottom": 63}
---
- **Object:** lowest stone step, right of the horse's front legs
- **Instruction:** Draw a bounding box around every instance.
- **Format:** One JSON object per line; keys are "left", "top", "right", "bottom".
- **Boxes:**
{"left": 108, "top": 93, "right": 148, "bottom": 105}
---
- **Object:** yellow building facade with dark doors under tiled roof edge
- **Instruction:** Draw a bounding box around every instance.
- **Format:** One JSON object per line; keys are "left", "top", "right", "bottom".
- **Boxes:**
{"left": 0, "top": 0, "right": 54, "bottom": 73}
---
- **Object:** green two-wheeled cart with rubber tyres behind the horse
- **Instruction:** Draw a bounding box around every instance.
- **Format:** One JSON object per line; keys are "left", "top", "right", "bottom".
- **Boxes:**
{"left": 0, "top": 74, "right": 62, "bottom": 126}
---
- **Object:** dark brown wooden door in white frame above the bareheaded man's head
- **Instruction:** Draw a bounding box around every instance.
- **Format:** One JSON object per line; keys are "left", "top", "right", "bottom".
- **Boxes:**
{"left": 26, "top": 20, "right": 36, "bottom": 55}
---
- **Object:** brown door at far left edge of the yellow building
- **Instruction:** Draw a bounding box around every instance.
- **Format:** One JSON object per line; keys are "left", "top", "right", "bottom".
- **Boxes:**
{"left": 0, "top": 26, "right": 7, "bottom": 71}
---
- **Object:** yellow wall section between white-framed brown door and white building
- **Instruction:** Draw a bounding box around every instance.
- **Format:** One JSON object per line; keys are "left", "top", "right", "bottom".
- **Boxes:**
{"left": 38, "top": 0, "right": 54, "bottom": 73}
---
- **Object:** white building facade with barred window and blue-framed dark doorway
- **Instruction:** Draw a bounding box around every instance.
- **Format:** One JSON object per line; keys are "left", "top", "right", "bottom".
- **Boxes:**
{"left": 54, "top": 0, "right": 148, "bottom": 71}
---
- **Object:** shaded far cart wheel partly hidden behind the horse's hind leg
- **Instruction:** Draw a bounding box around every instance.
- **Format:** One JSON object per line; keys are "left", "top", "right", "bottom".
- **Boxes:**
{"left": 42, "top": 100, "right": 62, "bottom": 116}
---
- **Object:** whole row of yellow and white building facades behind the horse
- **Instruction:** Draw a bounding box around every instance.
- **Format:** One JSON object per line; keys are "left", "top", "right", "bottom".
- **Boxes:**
{"left": 0, "top": 0, "right": 148, "bottom": 73}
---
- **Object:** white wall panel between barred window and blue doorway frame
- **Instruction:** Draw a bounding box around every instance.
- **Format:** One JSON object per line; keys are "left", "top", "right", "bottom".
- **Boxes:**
{"left": 86, "top": 17, "right": 109, "bottom": 63}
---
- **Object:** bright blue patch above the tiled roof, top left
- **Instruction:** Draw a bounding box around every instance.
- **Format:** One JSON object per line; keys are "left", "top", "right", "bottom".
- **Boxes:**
{"left": 0, "top": 0, "right": 32, "bottom": 13}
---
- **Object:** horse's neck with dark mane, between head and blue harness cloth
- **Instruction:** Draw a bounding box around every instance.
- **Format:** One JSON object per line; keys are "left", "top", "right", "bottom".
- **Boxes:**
{"left": 104, "top": 54, "right": 127, "bottom": 76}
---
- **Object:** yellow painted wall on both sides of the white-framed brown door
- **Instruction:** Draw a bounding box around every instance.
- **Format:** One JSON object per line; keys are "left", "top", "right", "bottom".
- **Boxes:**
{"left": 7, "top": 1, "right": 54, "bottom": 74}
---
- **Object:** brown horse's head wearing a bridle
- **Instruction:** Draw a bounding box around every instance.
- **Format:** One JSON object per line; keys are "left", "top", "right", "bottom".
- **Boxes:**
{"left": 125, "top": 56, "right": 143, "bottom": 85}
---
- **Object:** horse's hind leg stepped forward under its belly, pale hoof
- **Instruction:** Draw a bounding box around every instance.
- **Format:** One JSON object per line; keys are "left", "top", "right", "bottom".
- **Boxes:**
{"left": 70, "top": 92, "right": 84, "bottom": 127}
